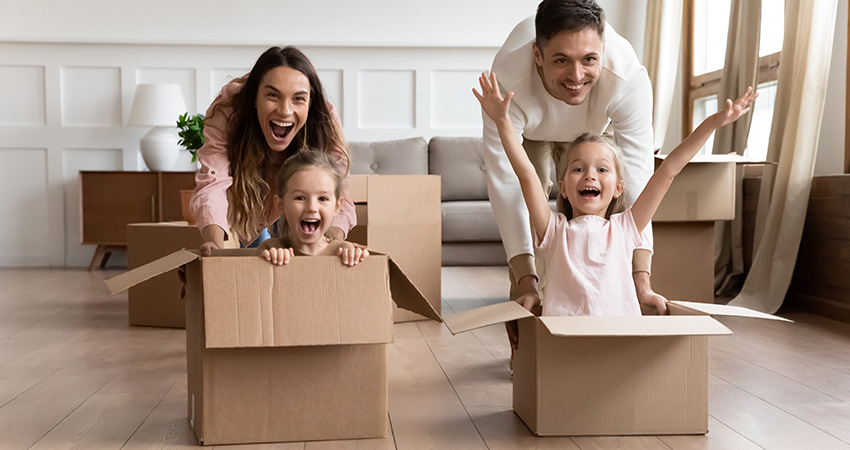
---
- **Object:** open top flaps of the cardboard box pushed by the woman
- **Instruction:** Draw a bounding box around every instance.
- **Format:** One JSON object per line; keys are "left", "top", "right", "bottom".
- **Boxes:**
{"left": 106, "top": 249, "right": 442, "bottom": 348}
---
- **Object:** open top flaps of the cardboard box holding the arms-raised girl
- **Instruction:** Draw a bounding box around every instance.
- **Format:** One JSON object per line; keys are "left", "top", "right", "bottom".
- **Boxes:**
{"left": 444, "top": 300, "right": 791, "bottom": 336}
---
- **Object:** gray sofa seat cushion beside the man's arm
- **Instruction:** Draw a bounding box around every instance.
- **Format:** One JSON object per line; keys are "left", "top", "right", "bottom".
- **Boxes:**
{"left": 440, "top": 200, "right": 502, "bottom": 242}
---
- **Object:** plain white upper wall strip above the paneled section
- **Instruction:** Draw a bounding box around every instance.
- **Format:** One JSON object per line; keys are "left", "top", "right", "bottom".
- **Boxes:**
{"left": 0, "top": 0, "right": 539, "bottom": 47}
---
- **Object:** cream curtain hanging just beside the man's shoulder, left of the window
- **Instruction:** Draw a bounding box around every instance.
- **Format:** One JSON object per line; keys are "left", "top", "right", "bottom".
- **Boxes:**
{"left": 643, "top": 0, "right": 682, "bottom": 150}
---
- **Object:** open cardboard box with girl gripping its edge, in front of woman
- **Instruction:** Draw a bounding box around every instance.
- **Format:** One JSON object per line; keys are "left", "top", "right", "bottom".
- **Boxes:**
{"left": 106, "top": 250, "right": 440, "bottom": 445}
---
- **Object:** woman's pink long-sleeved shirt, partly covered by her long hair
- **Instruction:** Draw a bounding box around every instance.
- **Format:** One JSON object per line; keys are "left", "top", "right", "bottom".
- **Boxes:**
{"left": 189, "top": 77, "right": 357, "bottom": 243}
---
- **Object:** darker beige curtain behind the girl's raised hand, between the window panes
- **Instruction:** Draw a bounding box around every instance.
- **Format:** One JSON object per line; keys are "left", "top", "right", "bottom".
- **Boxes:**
{"left": 712, "top": 0, "right": 761, "bottom": 295}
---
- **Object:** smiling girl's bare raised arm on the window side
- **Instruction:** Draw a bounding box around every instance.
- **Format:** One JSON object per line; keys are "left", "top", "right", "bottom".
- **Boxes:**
{"left": 632, "top": 87, "right": 758, "bottom": 230}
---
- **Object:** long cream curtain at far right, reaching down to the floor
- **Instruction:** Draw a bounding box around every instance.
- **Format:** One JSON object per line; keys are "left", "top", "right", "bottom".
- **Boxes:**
{"left": 731, "top": 0, "right": 838, "bottom": 313}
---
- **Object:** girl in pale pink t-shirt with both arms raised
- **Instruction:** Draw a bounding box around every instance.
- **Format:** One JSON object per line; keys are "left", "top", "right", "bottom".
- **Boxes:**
{"left": 473, "top": 73, "right": 758, "bottom": 320}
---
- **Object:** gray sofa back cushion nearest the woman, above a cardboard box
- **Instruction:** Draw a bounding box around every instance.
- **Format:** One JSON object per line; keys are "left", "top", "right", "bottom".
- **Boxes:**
{"left": 348, "top": 137, "right": 428, "bottom": 175}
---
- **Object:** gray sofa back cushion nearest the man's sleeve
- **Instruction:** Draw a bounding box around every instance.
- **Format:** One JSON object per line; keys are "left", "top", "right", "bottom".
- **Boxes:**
{"left": 428, "top": 137, "right": 490, "bottom": 201}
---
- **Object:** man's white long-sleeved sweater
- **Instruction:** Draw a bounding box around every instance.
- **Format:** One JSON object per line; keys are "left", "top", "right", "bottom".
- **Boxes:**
{"left": 482, "top": 16, "right": 653, "bottom": 260}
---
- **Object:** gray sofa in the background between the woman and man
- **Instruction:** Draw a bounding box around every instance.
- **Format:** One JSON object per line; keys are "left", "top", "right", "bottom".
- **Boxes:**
{"left": 349, "top": 137, "right": 507, "bottom": 266}
